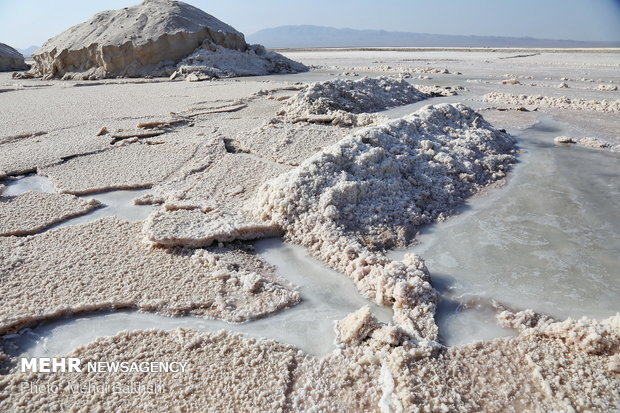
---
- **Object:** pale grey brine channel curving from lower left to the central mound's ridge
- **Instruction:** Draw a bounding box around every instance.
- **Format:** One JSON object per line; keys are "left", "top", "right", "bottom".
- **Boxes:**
{"left": 2, "top": 239, "right": 392, "bottom": 357}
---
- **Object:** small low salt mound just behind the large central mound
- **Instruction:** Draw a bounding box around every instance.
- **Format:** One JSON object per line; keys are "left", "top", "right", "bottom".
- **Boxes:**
{"left": 286, "top": 76, "right": 429, "bottom": 123}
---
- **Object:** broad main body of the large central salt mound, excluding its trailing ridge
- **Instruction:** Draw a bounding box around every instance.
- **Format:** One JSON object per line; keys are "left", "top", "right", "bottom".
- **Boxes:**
{"left": 260, "top": 104, "right": 515, "bottom": 247}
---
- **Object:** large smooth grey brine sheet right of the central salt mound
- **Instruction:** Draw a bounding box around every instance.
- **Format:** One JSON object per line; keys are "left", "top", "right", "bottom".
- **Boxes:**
{"left": 392, "top": 119, "right": 620, "bottom": 345}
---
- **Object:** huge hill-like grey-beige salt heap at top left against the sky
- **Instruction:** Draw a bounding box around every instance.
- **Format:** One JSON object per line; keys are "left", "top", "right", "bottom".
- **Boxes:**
{"left": 25, "top": 0, "right": 307, "bottom": 79}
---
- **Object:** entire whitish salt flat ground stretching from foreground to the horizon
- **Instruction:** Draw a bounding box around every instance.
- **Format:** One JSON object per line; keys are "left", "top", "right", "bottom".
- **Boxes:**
{"left": 0, "top": 50, "right": 620, "bottom": 411}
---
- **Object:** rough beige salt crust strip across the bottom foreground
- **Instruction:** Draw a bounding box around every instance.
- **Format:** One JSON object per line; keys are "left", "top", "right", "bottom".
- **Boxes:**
{"left": 0, "top": 316, "right": 620, "bottom": 412}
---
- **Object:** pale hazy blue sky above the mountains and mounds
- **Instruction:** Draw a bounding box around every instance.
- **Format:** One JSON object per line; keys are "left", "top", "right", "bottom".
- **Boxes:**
{"left": 0, "top": 0, "right": 620, "bottom": 48}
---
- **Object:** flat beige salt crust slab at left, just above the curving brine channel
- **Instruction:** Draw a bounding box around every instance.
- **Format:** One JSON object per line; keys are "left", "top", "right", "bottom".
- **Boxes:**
{"left": 0, "top": 218, "right": 299, "bottom": 332}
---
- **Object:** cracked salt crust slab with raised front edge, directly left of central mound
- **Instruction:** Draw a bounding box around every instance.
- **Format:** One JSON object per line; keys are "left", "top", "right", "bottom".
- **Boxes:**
{"left": 143, "top": 141, "right": 288, "bottom": 247}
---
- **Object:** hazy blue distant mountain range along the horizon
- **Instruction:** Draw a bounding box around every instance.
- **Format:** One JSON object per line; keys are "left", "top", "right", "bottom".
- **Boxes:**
{"left": 246, "top": 26, "right": 620, "bottom": 49}
